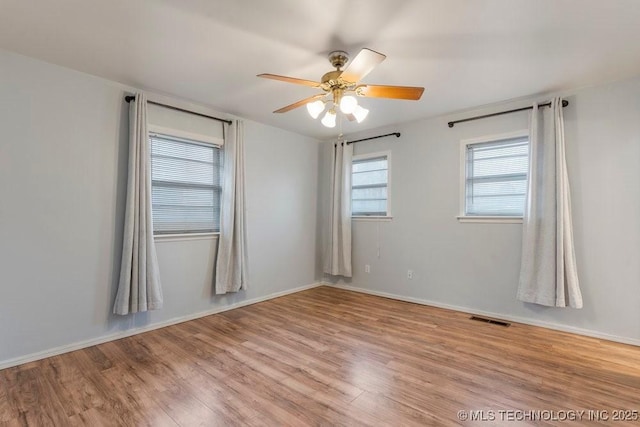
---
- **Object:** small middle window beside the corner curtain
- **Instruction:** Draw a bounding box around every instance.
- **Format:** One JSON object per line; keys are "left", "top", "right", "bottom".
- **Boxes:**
{"left": 351, "top": 152, "right": 391, "bottom": 217}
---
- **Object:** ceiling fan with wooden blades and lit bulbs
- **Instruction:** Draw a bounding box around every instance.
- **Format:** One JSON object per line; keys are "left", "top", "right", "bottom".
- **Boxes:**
{"left": 258, "top": 48, "right": 424, "bottom": 128}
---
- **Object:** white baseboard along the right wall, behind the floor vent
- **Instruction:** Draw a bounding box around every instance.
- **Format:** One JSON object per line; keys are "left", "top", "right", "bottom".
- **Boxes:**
{"left": 321, "top": 282, "right": 640, "bottom": 346}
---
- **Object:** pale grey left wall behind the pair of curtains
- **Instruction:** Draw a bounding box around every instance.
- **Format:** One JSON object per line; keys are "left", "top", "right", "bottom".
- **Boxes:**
{"left": 0, "top": 51, "right": 318, "bottom": 366}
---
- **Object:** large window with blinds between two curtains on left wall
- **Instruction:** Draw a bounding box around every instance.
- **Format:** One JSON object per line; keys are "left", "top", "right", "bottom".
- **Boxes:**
{"left": 149, "top": 133, "right": 221, "bottom": 234}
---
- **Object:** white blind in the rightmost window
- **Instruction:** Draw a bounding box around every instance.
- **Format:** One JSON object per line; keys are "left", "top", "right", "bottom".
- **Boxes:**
{"left": 465, "top": 136, "right": 529, "bottom": 216}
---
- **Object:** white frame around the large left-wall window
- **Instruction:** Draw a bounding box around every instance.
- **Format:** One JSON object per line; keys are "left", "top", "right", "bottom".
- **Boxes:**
{"left": 147, "top": 124, "right": 224, "bottom": 241}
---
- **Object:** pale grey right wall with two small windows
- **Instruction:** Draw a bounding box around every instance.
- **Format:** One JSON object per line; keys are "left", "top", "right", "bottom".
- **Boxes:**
{"left": 320, "top": 78, "right": 640, "bottom": 344}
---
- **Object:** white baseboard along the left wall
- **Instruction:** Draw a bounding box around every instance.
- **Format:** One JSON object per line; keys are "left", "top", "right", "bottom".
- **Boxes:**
{"left": 0, "top": 282, "right": 325, "bottom": 370}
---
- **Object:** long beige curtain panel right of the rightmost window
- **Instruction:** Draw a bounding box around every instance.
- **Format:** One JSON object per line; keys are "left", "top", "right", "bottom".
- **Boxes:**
{"left": 517, "top": 98, "right": 582, "bottom": 308}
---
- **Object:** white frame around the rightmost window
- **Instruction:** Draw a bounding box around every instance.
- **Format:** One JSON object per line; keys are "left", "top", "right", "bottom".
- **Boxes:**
{"left": 457, "top": 129, "right": 531, "bottom": 224}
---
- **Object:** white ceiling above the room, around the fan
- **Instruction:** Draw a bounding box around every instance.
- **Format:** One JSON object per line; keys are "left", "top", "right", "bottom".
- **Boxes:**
{"left": 0, "top": 0, "right": 640, "bottom": 138}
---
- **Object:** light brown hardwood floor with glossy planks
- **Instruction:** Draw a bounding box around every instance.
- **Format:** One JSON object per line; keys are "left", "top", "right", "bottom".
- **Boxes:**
{"left": 0, "top": 287, "right": 640, "bottom": 426}
